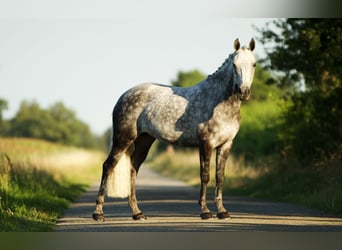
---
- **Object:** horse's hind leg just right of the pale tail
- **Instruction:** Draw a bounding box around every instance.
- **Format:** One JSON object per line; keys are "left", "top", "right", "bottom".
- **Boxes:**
{"left": 128, "top": 134, "right": 155, "bottom": 220}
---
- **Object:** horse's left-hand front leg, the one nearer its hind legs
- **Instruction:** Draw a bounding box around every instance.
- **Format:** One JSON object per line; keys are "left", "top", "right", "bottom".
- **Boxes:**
{"left": 198, "top": 142, "right": 213, "bottom": 220}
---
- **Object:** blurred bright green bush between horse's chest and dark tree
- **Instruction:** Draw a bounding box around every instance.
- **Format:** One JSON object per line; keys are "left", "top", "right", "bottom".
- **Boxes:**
{"left": 232, "top": 66, "right": 282, "bottom": 161}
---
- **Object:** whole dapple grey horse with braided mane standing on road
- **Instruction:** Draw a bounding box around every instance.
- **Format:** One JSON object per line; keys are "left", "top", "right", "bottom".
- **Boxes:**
{"left": 93, "top": 39, "right": 256, "bottom": 221}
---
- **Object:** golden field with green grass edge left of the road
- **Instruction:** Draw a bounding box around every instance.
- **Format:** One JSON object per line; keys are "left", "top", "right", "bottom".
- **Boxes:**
{"left": 0, "top": 138, "right": 104, "bottom": 232}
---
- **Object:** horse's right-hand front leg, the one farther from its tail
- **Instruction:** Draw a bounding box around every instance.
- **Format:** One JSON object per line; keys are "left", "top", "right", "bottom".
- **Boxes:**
{"left": 215, "top": 141, "right": 232, "bottom": 219}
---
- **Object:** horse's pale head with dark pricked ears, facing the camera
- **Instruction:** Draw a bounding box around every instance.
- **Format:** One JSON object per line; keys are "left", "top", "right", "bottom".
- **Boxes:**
{"left": 233, "top": 38, "right": 256, "bottom": 100}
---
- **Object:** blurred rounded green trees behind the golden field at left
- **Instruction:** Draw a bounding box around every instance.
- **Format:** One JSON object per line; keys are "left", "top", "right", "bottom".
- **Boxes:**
{"left": 0, "top": 101, "right": 100, "bottom": 148}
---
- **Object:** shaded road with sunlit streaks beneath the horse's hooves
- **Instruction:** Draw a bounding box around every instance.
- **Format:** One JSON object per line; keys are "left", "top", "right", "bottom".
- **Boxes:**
{"left": 55, "top": 166, "right": 342, "bottom": 232}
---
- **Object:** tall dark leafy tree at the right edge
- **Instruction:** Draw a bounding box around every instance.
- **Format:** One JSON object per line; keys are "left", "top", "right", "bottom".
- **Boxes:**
{"left": 259, "top": 19, "right": 342, "bottom": 165}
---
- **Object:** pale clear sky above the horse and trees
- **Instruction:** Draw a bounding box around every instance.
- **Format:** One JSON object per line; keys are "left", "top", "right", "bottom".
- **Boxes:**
{"left": 0, "top": 0, "right": 271, "bottom": 134}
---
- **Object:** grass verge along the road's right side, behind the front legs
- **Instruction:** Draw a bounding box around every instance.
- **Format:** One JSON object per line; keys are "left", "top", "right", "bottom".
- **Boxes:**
{"left": 148, "top": 148, "right": 342, "bottom": 216}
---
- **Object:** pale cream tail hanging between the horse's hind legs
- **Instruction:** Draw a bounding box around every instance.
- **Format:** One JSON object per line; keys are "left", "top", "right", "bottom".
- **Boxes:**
{"left": 106, "top": 147, "right": 133, "bottom": 198}
